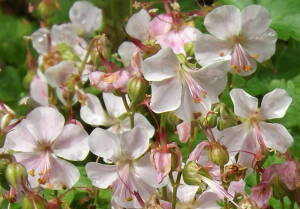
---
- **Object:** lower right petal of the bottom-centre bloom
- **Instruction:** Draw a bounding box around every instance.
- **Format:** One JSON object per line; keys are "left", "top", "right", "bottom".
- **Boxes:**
{"left": 133, "top": 153, "right": 161, "bottom": 188}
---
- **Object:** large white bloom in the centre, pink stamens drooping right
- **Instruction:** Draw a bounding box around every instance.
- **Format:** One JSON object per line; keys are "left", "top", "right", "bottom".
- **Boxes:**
{"left": 142, "top": 48, "right": 227, "bottom": 121}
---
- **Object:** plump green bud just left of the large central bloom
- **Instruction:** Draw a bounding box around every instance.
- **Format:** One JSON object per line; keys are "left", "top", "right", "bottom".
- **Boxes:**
{"left": 127, "top": 76, "right": 148, "bottom": 104}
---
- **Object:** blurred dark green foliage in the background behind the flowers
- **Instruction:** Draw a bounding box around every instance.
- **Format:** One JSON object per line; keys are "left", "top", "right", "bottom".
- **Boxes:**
{"left": 0, "top": 0, "right": 300, "bottom": 208}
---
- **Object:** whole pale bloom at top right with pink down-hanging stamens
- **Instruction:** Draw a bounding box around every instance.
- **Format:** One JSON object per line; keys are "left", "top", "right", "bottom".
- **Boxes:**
{"left": 195, "top": 5, "right": 277, "bottom": 76}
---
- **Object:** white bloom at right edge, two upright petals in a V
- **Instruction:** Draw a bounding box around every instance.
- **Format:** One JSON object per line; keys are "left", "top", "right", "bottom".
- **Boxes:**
{"left": 220, "top": 89, "right": 293, "bottom": 166}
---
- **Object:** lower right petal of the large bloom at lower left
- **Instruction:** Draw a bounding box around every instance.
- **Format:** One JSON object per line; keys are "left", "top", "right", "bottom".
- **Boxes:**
{"left": 45, "top": 157, "right": 80, "bottom": 190}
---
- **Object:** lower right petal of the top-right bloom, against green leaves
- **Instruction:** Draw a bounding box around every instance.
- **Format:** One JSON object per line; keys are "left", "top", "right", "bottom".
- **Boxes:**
{"left": 242, "top": 29, "right": 277, "bottom": 62}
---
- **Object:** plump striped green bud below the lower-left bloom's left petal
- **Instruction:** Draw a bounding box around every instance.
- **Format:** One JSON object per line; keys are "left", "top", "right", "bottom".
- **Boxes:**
{"left": 5, "top": 163, "right": 27, "bottom": 188}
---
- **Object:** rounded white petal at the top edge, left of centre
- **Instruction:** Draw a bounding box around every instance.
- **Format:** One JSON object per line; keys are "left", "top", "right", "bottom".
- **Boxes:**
{"left": 69, "top": 1, "right": 102, "bottom": 34}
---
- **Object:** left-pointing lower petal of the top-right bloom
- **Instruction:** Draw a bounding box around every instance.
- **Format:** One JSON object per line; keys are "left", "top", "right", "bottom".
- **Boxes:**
{"left": 195, "top": 34, "right": 233, "bottom": 65}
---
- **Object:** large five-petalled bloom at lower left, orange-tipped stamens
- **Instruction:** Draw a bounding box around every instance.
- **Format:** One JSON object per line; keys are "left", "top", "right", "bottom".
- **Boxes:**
{"left": 5, "top": 107, "right": 89, "bottom": 189}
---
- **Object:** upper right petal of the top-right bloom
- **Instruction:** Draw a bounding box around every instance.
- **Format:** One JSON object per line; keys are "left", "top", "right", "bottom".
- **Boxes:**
{"left": 241, "top": 5, "right": 272, "bottom": 39}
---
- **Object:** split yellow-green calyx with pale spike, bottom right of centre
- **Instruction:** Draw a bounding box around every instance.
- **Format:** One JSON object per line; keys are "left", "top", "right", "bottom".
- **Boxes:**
{"left": 182, "top": 161, "right": 210, "bottom": 185}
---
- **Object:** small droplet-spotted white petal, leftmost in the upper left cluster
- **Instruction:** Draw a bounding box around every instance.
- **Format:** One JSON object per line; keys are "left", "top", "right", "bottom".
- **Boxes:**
{"left": 31, "top": 28, "right": 50, "bottom": 54}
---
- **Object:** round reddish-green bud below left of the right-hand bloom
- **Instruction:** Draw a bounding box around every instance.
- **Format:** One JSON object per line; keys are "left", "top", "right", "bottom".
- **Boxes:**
{"left": 208, "top": 143, "right": 229, "bottom": 166}
